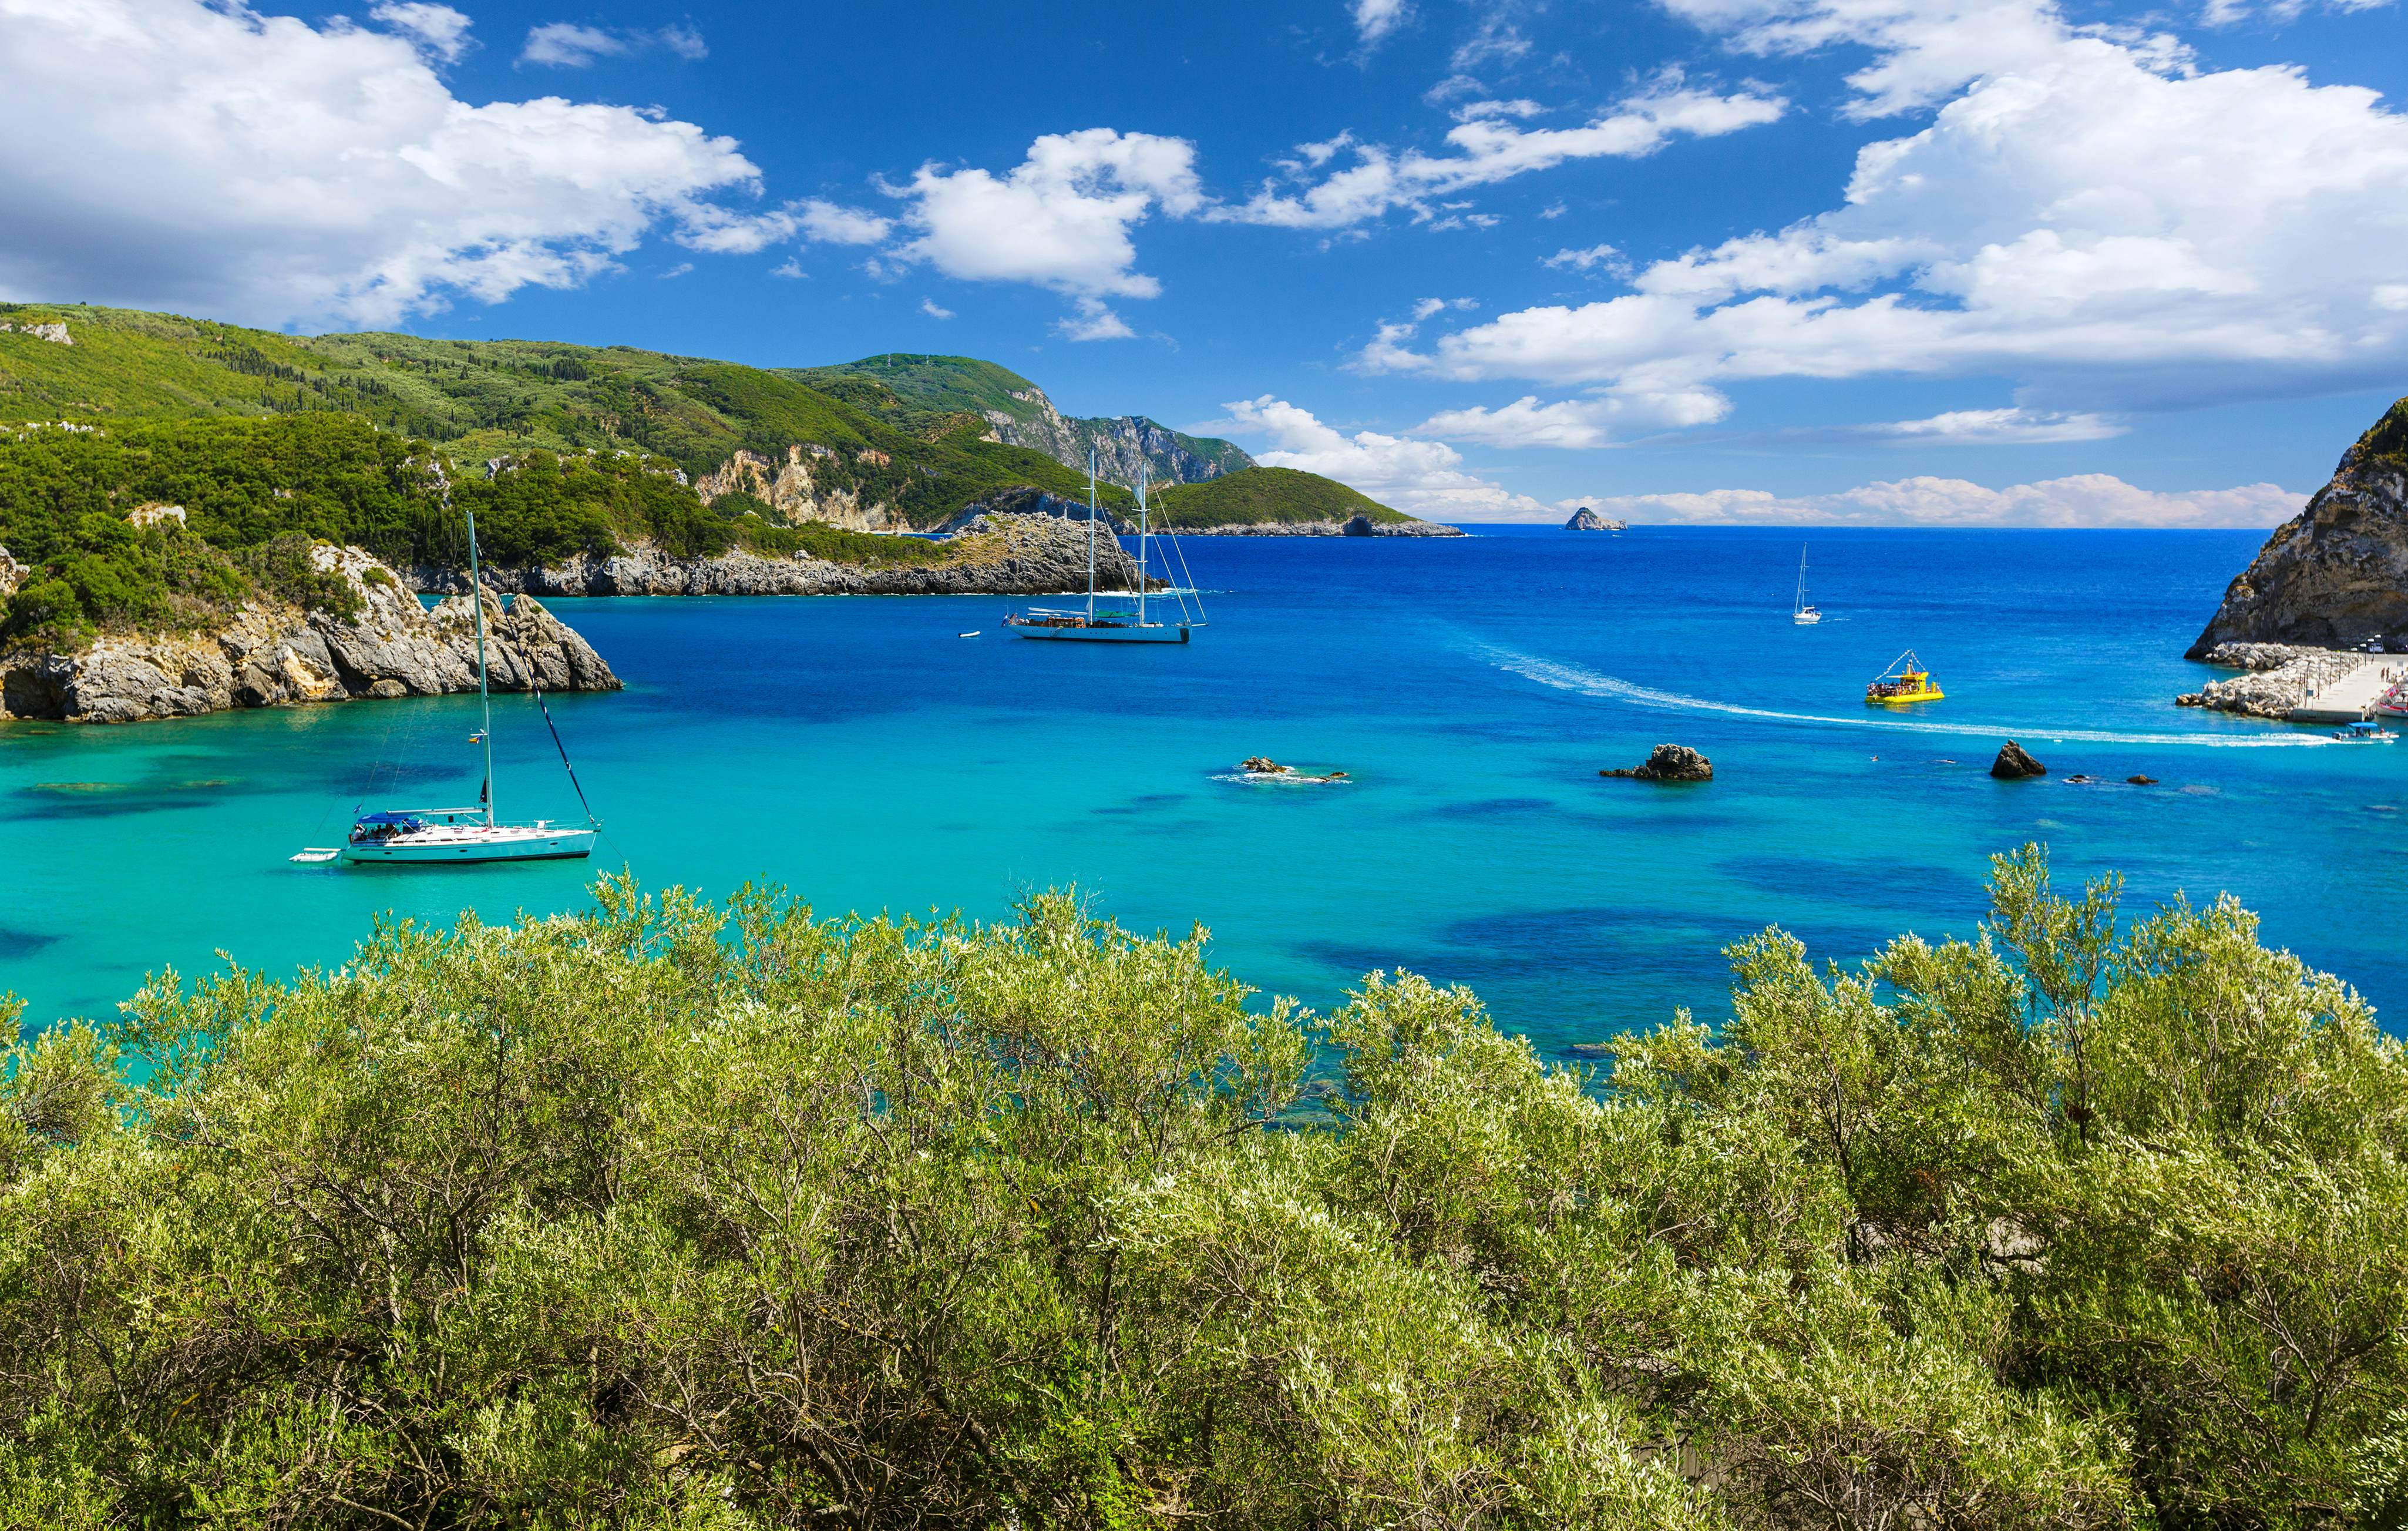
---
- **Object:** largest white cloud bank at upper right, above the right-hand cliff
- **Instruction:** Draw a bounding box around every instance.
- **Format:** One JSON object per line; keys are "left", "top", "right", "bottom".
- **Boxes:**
{"left": 1361, "top": 0, "right": 2408, "bottom": 441}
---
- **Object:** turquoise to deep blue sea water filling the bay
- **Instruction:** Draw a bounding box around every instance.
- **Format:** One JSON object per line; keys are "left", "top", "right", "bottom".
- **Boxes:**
{"left": 0, "top": 527, "right": 2408, "bottom": 1045}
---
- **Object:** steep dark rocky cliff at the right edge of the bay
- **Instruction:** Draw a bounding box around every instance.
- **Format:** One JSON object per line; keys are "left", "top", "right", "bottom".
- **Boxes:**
{"left": 2187, "top": 399, "right": 2408, "bottom": 660}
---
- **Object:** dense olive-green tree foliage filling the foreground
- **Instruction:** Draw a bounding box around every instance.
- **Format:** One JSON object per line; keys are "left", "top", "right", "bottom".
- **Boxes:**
{"left": 0, "top": 850, "right": 2408, "bottom": 1531}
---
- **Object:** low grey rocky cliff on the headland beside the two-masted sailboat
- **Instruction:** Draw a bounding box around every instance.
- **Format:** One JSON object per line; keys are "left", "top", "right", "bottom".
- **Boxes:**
{"left": 414, "top": 505, "right": 1136, "bottom": 597}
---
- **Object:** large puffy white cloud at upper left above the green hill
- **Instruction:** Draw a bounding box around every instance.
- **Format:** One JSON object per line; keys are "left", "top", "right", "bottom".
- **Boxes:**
{"left": 0, "top": 0, "right": 783, "bottom": 325}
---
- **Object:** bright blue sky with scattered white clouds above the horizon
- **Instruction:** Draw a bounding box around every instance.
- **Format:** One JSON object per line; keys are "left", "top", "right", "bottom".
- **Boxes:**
{"left": 0, "top": 0, "right": 2408, "bottom": 525}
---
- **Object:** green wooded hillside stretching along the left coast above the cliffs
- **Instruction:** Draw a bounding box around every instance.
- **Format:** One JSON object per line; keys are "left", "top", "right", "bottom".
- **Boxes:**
{"left": 0, "top": 303, "right": 1397, "bottom": 643}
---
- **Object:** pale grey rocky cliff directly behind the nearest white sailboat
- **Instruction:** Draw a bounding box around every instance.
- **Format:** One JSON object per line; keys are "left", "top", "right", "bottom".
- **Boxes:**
{"left": 0, "top": 546, "right": 619, "bottom": 722}
